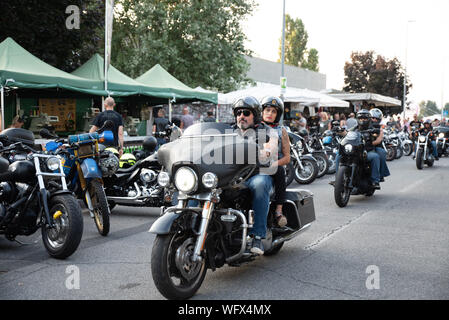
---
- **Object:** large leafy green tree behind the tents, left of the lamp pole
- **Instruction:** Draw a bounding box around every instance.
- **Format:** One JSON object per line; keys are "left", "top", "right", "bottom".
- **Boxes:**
{"left": 111, "top": 0, "right": 255, "bottom": 92}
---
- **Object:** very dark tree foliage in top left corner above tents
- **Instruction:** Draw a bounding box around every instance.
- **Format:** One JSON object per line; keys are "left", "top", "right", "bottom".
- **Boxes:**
{"left": 0, "top": 0, "right": 104, "bottom": 72}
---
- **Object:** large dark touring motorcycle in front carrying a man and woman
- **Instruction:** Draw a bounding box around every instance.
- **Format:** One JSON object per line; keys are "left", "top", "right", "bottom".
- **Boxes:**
{"left": 150, "top": 122, "right": 315, "bottom": 299}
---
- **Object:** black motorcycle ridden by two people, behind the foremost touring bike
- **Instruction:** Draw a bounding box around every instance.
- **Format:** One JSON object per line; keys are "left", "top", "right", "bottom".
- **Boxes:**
{"left": 334, "top": 129, "right": 379, "bottom": 207}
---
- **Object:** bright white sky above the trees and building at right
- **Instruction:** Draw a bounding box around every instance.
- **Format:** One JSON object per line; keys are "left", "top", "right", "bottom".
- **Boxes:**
{"left": 243, "top": 0, "right": 449, "bottom": 107}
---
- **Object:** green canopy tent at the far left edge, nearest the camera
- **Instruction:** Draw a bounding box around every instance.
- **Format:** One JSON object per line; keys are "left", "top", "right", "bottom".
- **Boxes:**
{"left": 0, "top": 38, "right": 108, "bottom": 129}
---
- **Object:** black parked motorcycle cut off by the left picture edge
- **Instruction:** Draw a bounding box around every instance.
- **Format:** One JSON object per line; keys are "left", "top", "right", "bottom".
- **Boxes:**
{"left": 0, "top": 128, "right": 83, "bottom": 259}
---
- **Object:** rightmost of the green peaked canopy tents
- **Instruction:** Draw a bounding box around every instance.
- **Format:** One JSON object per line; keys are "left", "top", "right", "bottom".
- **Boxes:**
{"left": 135, "top": 64, "right": 218, "bottom": 121}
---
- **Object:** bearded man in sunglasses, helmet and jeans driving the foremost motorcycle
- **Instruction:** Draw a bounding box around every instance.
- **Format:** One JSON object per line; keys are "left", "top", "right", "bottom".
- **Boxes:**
{"left": 232, "top": 97, "right": 277, "bottom": 255}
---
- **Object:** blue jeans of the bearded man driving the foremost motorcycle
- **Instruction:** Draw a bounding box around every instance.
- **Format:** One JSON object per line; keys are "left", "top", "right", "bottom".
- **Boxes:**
{"left": 245, "top": 174, "right": 273, "bottom": 238}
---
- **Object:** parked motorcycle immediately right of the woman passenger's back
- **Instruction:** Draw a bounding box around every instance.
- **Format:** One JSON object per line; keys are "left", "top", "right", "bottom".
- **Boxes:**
{"left": 286, "top": 132, "right": 319, "bottom": 184}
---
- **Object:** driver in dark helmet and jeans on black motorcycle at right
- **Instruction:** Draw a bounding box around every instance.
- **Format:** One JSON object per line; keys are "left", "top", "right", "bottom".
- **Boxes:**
{"left": 329, "top": 109, "right": 382, "bottom": 190}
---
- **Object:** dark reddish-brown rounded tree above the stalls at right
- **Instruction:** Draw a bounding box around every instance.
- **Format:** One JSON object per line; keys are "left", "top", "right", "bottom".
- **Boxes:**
{"left": 343, "top": 51, "right": 412, "bottom": 104}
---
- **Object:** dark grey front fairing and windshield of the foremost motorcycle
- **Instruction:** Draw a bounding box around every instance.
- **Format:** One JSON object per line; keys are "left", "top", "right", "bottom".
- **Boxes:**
{"left": 157, "top": 122, "right": 257, "bottom": 187}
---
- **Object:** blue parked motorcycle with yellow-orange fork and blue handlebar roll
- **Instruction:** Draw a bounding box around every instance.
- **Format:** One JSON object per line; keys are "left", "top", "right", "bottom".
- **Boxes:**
{"left": 40, "top": 124, "right": 118, "bottom": 236}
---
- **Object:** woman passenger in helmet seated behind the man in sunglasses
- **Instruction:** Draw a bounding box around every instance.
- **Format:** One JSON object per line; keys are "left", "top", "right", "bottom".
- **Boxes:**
{"left": 261, "top": 96, "right": 290, "bottom": 227}
